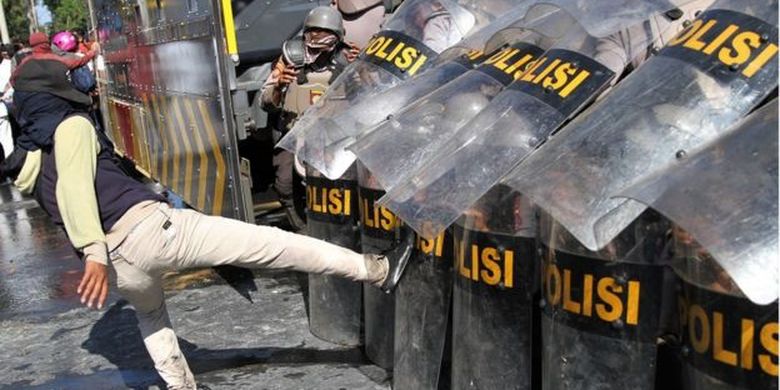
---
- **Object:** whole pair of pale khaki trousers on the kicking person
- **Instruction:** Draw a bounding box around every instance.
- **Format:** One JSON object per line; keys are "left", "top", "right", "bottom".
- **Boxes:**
{"left": 110, "top": 203, "right": 367, "bottom": 389}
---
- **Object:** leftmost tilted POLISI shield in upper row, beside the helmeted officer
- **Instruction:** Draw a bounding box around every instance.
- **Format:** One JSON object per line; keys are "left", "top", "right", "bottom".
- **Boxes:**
{"left": 278, "top": 0, "right": 512, "bottom": 174}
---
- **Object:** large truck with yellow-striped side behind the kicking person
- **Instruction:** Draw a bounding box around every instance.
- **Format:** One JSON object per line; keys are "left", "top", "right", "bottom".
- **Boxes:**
{"left": 89, "top": 0, "right": 330, "bottom": 222}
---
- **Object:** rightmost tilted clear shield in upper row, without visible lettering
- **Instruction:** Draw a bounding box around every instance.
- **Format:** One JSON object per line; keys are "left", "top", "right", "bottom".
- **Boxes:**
{"left": 621, "top": 100, "right": 778, "bottom": 304}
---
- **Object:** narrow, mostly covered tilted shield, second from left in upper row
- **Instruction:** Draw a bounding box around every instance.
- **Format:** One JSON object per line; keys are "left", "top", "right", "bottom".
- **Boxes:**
{"left": 307, "top": 1, "right": 552, "bottom": 177}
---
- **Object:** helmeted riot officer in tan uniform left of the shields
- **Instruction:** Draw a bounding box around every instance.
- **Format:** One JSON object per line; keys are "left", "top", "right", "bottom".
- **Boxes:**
{"left": 261, "top": 7, "right": 358, "bottom": 228}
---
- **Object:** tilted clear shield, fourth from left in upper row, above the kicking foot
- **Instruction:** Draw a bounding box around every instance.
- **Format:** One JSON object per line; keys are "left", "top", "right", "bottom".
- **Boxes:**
{"left": 380, "top": 13, "right": 654, "bottom": 236}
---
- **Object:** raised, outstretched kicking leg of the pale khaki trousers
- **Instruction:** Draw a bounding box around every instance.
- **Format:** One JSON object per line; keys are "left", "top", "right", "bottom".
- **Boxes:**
{"left": 122, "top": 206, "right": 368, "bottom": 281}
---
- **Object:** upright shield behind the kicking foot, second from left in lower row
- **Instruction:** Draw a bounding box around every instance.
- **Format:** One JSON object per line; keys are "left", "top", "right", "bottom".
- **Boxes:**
{"left": 357, "top": 164, "right": 400, "bottom": 369}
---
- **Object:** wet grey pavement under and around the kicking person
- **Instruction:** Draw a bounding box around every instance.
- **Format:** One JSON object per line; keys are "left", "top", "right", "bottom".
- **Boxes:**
{"left": 0, "top": 184, "right": 389, "bottom": 389}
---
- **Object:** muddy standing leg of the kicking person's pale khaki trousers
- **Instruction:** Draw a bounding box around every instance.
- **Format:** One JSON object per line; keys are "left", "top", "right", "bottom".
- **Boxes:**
{"left": 111, "top": 252, "right": 195, "bottom": 390}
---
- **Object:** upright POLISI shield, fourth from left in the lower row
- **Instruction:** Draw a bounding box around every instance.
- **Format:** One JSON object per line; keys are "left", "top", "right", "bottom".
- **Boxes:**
{"left": 452, "top": 186, "right": 538, "bottom": 389}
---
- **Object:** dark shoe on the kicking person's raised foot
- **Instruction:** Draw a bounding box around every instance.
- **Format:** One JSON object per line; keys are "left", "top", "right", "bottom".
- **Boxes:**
{"left": 365, "top": 226, "right": 414, "bottom": 294}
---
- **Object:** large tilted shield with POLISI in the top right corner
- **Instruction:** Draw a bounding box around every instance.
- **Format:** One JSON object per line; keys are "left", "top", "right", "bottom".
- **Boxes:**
{"left": 505, "top": 0, "right": 778, "bottom": 250}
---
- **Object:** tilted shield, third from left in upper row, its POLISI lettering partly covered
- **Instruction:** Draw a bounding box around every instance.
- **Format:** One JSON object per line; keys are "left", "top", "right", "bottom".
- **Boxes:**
{"left": 348, "top": 8, "right": 574, "bottom": 189}
